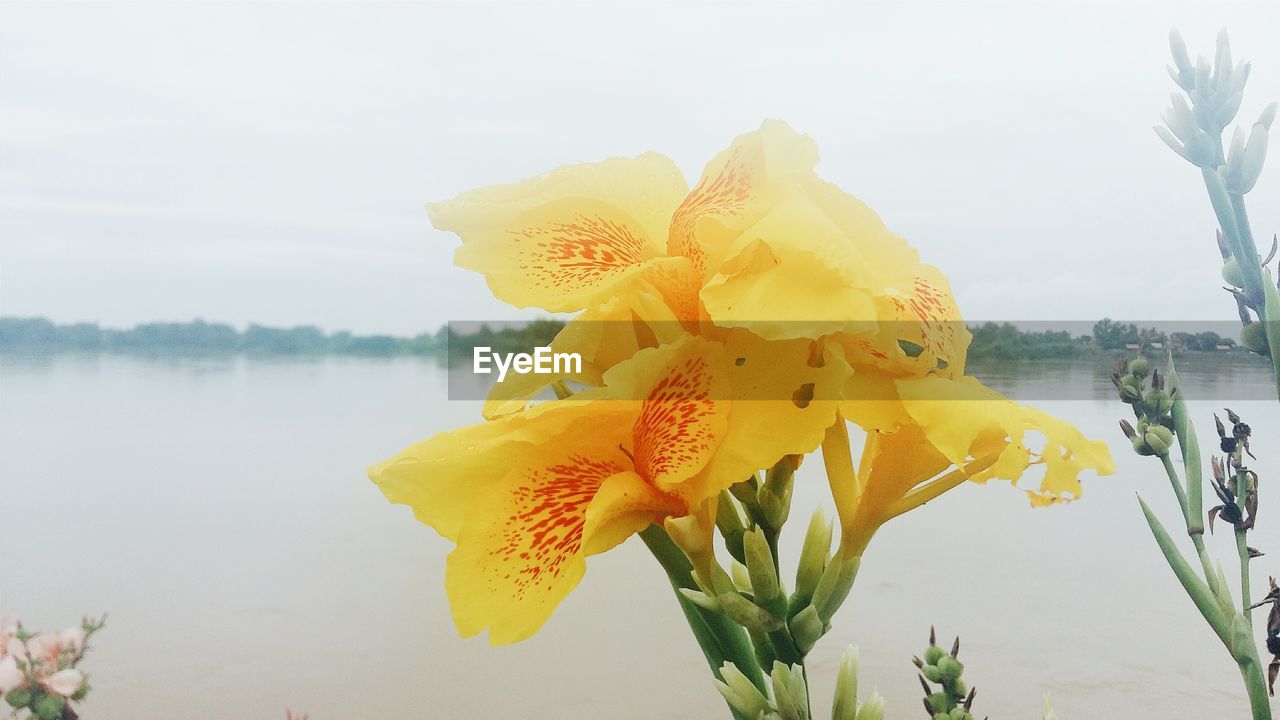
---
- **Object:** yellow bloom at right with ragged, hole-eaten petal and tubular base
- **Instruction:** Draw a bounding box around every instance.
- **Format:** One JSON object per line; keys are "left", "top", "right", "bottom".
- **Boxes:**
{"left": 823, "top": 373, "right": 1115, "bottom": 553}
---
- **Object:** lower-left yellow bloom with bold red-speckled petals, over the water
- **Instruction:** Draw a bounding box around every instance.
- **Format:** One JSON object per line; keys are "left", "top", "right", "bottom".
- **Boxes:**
{"left": 370, "top": 332, "right": 850, "bottom": 644}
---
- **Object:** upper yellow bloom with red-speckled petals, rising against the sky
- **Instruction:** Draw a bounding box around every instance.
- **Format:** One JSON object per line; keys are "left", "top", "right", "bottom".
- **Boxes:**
{"left": 430, "top": 120, "right": 945, "bottom": 418}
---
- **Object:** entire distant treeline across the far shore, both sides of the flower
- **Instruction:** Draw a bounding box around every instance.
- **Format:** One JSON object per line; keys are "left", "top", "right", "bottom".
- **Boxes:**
{"left": 0, "top": 318, "right": 1235, "bottom": 361}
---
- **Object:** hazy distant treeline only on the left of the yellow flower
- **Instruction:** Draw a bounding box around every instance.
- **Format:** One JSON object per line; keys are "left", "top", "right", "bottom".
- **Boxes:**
{"left": 0, "top": 318, "right": 563, "bottom": 359}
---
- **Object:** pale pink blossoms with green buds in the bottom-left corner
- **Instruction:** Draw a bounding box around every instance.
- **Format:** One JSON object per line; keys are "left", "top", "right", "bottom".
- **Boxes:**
{"left": 0, "top": 615, "right": 106, "bottom": 720}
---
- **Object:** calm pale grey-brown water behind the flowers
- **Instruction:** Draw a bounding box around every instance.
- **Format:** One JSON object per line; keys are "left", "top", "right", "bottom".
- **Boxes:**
{"left": 0, "top": 356, "right": 1280, "bottom": 720}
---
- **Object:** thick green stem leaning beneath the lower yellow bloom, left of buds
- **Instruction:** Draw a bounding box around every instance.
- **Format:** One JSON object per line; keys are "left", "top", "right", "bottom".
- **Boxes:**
{"left": 640, "top": 525, "right": 768, "bottom": 693}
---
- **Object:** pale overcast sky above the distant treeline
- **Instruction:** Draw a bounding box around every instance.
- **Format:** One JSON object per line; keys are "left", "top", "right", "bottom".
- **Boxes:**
{"left": 0, "top": 0, "right": 1280, "bottom": 333}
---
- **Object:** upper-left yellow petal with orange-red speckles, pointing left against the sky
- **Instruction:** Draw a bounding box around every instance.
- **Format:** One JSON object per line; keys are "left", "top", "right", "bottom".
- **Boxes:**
{"left": 429, "top": 152, "right": 686, "bottom": 311}
